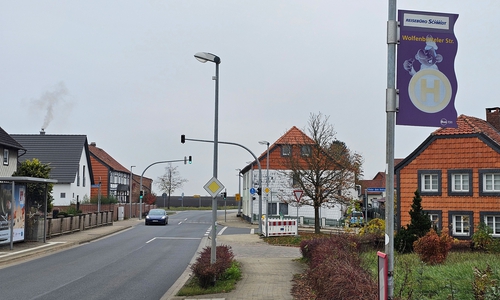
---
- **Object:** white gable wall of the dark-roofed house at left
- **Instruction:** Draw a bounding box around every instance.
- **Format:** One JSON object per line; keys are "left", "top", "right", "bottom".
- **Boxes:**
{"left": 52, "top": 147, "right": 91, "bottom": 206}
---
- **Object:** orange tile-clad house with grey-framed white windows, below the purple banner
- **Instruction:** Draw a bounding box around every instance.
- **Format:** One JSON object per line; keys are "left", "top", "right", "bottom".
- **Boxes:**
{"left": 395, "top": 107, "right": 500, "bottom": 239}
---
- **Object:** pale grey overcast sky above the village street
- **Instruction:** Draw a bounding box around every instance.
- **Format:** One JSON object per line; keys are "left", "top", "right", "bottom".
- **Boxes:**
{"left": 0, "top": 0, "right": 500, "bottom": 195}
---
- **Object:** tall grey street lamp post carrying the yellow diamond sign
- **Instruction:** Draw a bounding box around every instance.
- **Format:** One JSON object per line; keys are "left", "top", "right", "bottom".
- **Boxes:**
{"left": 194, "top": 52, "right": 220, "bottom": 264}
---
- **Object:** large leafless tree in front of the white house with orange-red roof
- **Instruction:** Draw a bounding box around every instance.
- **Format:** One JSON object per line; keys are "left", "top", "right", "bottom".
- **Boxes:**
{"left": 282, "top": 113, "right": 363, "bottom": 233}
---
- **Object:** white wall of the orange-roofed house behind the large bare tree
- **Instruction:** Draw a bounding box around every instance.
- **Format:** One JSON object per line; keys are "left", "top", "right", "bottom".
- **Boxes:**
{"left": 241, "top": 169, "right": 357, "bottom": 223}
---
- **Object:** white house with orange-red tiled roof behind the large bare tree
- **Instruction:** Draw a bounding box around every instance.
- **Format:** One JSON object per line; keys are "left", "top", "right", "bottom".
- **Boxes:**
{"left": 240, "top": 126, "right": 356, "bottom": 222}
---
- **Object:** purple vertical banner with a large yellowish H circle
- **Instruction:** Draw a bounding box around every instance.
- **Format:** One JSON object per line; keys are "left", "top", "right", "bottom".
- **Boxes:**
{"left": 396, "top": 10, "right": 458, "bottom": 127}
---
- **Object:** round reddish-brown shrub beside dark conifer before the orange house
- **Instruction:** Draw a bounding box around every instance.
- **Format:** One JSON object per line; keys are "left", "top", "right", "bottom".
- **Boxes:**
{"left": 413, "top": 229, "right": 453, "bottom": 265}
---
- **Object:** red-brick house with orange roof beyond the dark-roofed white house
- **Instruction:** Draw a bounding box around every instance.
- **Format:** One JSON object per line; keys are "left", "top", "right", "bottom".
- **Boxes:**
{"left": 89, "top": 142, "right": 153, "bottom": 203}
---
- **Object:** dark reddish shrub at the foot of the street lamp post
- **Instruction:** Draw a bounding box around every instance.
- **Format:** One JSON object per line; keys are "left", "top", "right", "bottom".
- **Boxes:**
{"left": 191, "top": 245, "right": 234, "bottom": 288}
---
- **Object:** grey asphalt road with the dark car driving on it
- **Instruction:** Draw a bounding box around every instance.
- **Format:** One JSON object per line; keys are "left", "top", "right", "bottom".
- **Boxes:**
{"left": 0, "top": 211, "right": 230, "bottom": 300}
